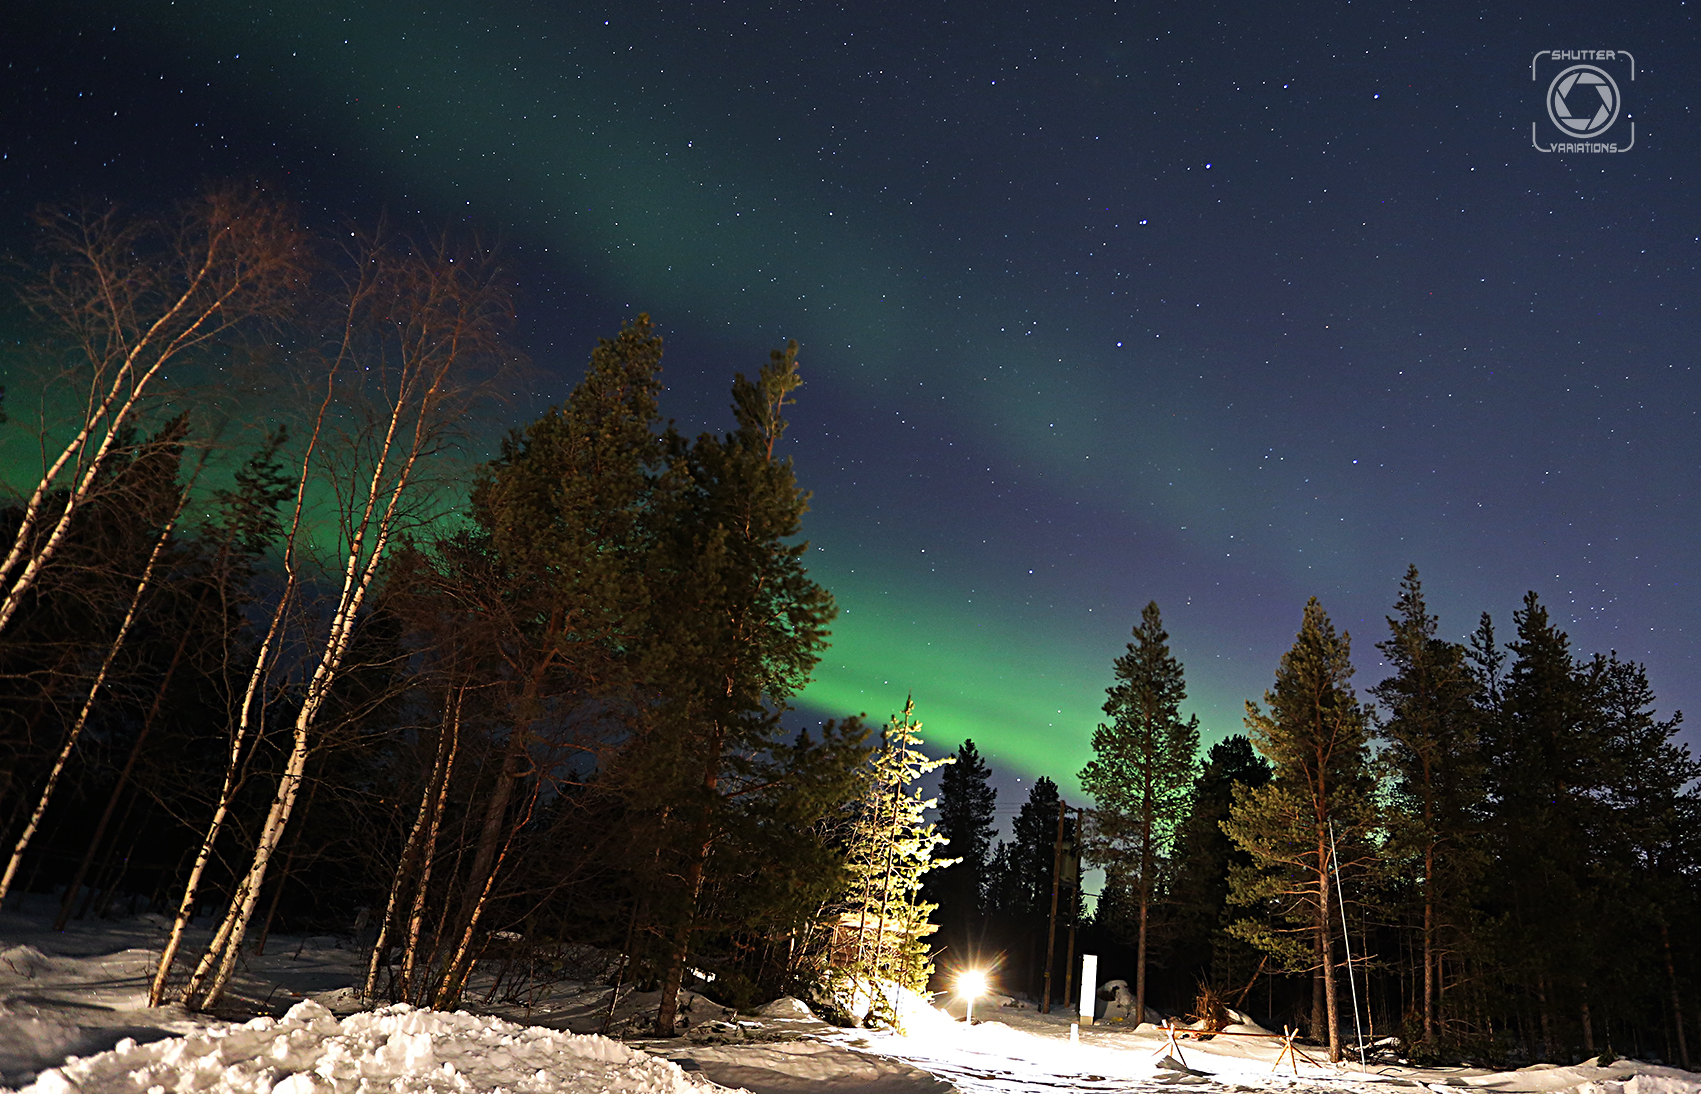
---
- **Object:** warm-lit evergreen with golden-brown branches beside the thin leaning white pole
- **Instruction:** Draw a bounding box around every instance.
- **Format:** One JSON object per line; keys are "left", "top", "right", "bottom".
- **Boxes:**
{"left": 1223, "top": 597, "right": 1373, "bottom": 1060}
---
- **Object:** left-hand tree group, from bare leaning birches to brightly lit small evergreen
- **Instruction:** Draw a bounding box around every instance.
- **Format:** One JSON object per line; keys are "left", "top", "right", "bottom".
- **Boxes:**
{"left": 0, "top": 187, "right": 937, "bottom": 1031}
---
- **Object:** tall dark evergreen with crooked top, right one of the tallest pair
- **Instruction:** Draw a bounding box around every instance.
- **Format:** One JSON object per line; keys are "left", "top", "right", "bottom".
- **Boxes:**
{"left": 645, "top": 342, "right": 837, "bottom": 1034}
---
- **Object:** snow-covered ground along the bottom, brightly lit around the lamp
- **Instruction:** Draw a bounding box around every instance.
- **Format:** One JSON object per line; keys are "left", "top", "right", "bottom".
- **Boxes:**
{"left": 0, "top": 903, "right": 1701, "bottom": 1094}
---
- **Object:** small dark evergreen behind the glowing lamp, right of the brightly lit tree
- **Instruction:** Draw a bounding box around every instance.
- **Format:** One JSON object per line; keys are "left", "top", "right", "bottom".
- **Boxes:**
{"left": 927, "top": 740, "right": 998, "bottom": 960}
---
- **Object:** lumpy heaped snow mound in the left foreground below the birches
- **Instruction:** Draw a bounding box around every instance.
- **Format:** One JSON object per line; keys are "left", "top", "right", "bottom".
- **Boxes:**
{"left": 24, "top": 1000, "right": 728, "bottom": 1094}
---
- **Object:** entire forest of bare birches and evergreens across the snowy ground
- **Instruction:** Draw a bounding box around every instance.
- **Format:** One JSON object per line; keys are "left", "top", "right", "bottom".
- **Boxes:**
{"left": 0, "top": 185, "right": 1701, "bottom": 1067}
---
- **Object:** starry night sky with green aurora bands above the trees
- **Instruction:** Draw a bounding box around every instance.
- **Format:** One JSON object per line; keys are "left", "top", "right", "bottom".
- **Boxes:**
{"left": 0, "top": 0, "right": 1701, "bottom": 789}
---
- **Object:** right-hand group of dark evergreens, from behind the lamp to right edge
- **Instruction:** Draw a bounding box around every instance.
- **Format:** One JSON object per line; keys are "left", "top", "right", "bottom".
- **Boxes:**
{"left": 934, "top": 581, "right": 1701, "bottom": 1067}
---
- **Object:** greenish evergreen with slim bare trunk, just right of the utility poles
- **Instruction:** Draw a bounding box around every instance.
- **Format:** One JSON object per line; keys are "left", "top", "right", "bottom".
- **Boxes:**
{"left": 1080, "top": 602, "right": 1199, "bottom": 1016}
